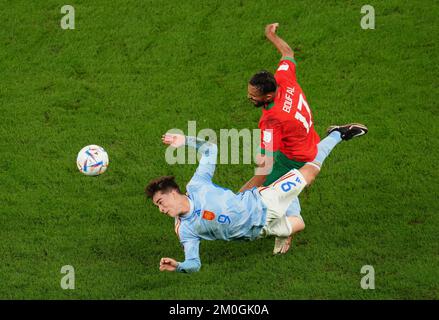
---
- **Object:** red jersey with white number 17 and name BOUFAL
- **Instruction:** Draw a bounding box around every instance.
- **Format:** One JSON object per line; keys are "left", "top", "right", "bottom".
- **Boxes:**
{"left": 259, "top": 59, "right": 320, "bottom": 162}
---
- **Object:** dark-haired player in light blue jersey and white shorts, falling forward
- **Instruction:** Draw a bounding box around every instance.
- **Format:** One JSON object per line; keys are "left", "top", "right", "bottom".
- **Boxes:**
{"left": 145, "top": 124, "right": 367, "bottom": 273}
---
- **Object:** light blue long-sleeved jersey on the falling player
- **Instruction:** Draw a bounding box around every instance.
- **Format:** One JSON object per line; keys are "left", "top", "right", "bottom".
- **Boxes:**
{"left": 175, "top": 137, "right": 267, "bottom": 272}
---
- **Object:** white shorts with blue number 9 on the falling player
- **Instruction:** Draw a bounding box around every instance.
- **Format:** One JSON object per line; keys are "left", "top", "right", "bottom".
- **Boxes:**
{"left": 259, "top": 169, "right": 306, "bottom": 237}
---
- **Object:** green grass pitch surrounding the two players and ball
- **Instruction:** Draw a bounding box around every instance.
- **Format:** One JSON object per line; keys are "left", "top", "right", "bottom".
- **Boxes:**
{"left": 0, "top": 0, "right": 439, "bottom": 299}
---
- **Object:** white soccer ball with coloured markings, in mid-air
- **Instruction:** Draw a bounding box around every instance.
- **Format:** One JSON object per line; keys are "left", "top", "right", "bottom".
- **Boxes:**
{"left": 76, "top": 144, "right": 109, "bottom": 176}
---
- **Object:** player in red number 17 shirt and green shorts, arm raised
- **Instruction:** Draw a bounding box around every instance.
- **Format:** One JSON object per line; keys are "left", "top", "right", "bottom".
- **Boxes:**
{"left": 240, "top": 23, "right": 320, "bottom": 254}
